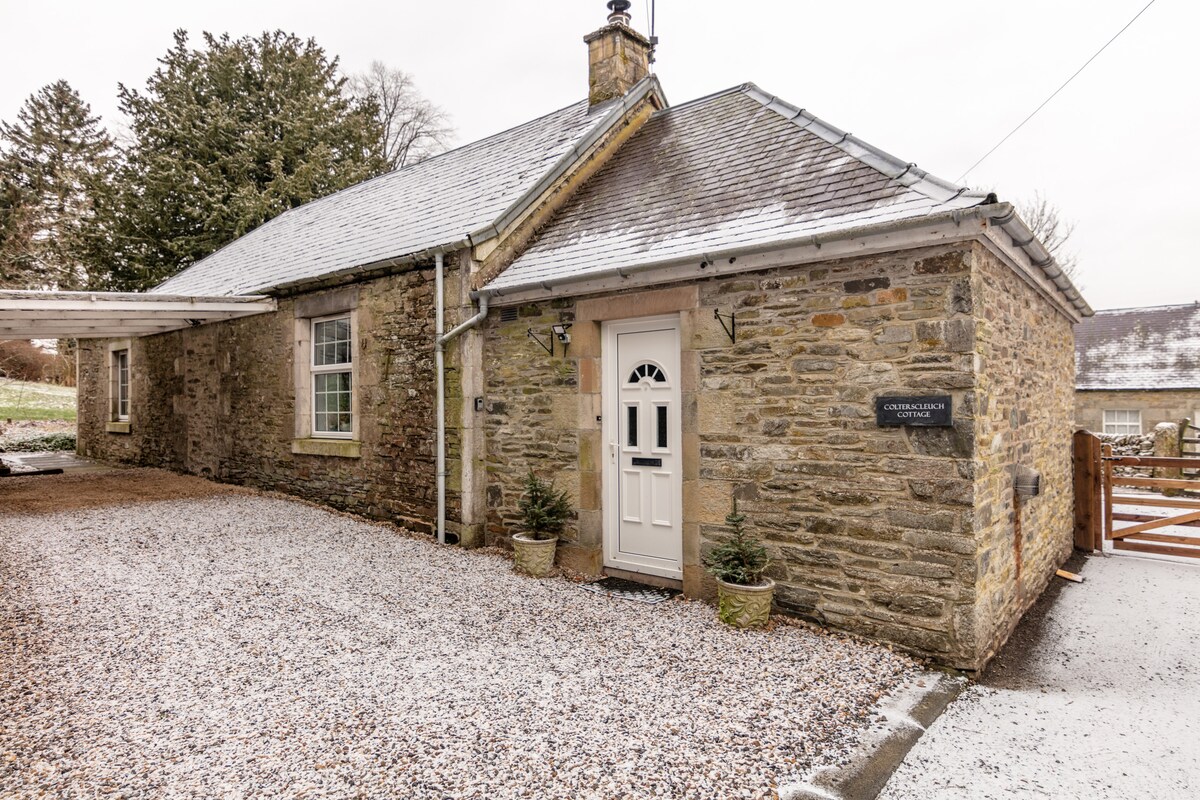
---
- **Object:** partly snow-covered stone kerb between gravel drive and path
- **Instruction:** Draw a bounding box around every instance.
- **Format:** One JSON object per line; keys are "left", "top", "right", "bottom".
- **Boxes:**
{"left": 779, "top": 670, "right": 967, "bottom": 800}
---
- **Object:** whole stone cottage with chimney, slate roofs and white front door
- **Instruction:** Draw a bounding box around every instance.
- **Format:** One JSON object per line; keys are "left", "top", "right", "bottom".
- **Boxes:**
{"left": 60, "top": 2, "right": 1091, "bottom": 669}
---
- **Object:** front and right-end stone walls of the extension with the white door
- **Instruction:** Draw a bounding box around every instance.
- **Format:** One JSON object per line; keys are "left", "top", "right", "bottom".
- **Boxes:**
{"left": 485, "top": 245, "right": 1073, "bottom": 669}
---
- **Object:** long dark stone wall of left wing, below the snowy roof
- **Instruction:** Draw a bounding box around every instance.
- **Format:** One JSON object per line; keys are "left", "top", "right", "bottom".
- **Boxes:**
{"left": 79, "top": 262, "right": 461, "bottom": 531}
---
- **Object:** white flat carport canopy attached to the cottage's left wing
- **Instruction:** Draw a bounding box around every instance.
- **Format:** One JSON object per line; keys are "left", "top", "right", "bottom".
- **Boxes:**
{"left": 0, "top": 291, "right": 276, "bottom": 339}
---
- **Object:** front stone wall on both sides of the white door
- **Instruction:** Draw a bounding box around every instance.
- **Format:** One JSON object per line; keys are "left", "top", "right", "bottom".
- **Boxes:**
{"left": 485, "top": 245, "right": 1017, "bottom": 668}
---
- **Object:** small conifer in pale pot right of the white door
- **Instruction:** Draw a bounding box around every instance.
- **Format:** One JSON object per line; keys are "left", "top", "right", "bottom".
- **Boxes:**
{"left": 704, "top": 500, "right": 775, "bottom": 627}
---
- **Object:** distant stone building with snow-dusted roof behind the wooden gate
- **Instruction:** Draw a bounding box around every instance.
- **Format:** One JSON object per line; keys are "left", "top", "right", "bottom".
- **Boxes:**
{"left": 1075, "top": 302, "right": 1200, "bottom": 435}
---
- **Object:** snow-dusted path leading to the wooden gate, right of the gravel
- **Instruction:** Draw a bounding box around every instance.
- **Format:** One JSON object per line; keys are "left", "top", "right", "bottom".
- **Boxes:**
{"left": 880, "top": 555, "right": 1200, "bottom": 800}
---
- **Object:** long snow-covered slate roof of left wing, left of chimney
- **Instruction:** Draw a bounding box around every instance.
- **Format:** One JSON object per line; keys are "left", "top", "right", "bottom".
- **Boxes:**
{"left": 152, "top": 90, "right": 658, "bottom": 295}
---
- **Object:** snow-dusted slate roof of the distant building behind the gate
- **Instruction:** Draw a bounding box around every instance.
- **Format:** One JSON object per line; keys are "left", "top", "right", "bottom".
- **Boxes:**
{"left": 1075, "top": 302, "right": 1200, "bottom": 390}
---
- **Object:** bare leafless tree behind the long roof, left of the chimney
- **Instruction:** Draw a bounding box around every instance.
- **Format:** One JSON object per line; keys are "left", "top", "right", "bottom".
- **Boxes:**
{"left": 346, "top": 61, "right": 454, "bottom": 169}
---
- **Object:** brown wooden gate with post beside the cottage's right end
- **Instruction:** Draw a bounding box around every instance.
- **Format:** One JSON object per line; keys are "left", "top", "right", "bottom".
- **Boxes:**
{"left": 1074, "top": 431, "right": 1200, "bottom": 559}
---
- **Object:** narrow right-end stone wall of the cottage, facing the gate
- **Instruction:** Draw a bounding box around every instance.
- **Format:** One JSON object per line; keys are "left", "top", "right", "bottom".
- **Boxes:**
{"left": 962, "top": 247, "right": 1075, "bottom": 666}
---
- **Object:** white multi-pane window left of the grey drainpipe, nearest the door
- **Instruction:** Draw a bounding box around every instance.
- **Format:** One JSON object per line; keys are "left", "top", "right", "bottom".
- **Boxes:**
{"left": 311, "top": 314, "right": 354, "bottom": 439}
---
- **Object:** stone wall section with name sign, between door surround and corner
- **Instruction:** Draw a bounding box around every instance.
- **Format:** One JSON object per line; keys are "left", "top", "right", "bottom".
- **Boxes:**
{"left": 698, "top": 246, "right": 974, "bottom": 666}
